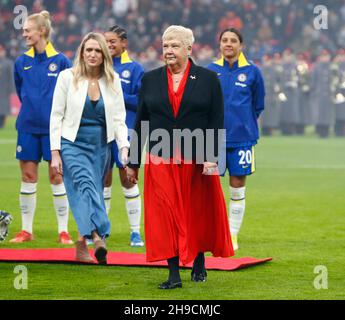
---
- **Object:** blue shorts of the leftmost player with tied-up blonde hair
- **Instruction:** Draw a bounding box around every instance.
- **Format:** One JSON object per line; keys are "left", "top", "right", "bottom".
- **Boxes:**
{"left": 16, "top": 132, "right": 51, "bottom": 162}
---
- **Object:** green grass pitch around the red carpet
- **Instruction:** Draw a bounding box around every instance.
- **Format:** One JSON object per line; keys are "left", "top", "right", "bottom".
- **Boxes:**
{"left": 0, "top": 118, "right": 345, "bottom": 300}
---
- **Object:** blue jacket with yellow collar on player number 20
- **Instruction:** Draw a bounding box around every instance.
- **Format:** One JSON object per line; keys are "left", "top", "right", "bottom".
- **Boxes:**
{"left": 208, "top": 53, "right": 265, "bottom": 148}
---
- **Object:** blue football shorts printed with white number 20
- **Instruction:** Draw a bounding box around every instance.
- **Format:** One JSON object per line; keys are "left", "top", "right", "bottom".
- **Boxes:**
{"left": 219, "top": 146, "right": 255, "bottom": 176}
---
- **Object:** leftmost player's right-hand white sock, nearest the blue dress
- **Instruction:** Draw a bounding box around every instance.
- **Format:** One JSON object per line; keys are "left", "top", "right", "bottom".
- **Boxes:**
{"left": 51, "top": 183, "right": 69, "bottom": 233}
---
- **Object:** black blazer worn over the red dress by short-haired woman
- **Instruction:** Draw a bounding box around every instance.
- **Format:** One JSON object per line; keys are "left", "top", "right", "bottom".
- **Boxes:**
{"left": 129, "top": 61, "right": 224, "bottom": 167}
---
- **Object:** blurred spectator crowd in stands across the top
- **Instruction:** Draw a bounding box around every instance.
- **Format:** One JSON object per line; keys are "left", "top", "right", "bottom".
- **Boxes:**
{"left": 0, "top": 0, "right": 345, "bottom": 69}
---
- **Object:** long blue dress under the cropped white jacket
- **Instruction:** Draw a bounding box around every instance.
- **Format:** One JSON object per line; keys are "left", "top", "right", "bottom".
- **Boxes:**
{"left": 61, "top": 96, "right": 110, "bottom": 238}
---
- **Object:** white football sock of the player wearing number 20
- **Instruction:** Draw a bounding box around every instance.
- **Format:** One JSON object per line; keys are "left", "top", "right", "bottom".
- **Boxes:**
{"left": 229, "top": 187, "right": 246, "bottom": 236}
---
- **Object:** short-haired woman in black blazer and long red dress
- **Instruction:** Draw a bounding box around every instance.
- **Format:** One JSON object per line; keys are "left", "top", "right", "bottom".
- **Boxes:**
{"left": 127, "top": 26, "right": 233, "bottom": 289}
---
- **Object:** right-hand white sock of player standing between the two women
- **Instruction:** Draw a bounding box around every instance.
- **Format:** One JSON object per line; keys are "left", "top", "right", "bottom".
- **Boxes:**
{"left": 122, "top": 185, "right": 141, "bottom": 232}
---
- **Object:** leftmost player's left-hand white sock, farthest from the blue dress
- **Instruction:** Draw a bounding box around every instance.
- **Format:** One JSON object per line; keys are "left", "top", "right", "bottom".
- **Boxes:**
{"left": 19, "top": 182, "right": 37, "bottom": 234}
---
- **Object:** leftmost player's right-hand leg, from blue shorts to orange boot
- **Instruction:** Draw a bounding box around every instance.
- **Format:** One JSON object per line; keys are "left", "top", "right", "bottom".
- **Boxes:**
{"left": 40, "top": 135, "right": 73, "bottom": 244}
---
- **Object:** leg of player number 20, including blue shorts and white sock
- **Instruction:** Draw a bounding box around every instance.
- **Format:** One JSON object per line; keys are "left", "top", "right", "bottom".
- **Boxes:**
{"left": 229, "top": 146, "right": 255, "bottom": 250}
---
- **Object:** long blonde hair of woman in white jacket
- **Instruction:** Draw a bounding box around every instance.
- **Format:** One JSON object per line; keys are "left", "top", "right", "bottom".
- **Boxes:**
{"left": 73, "top": 32, "right": 115, "bottom": 91}
